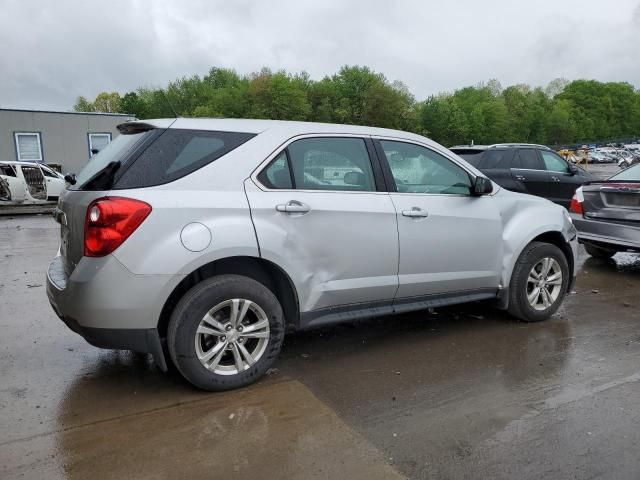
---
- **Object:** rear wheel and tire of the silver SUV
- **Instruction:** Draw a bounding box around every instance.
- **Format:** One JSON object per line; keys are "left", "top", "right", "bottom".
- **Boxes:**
{"left": 167, "top": 275, "right": 285, "bottom": 391}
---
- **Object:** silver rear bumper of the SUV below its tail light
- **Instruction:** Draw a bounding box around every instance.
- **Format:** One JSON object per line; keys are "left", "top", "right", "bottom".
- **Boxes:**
{"left": 47, "top": 256, "right": 182, "bottom": 370}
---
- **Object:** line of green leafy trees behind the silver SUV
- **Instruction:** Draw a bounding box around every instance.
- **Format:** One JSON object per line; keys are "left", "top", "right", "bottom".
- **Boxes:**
{"left": 74, "top": 66, "right": 640, "bottom": 146}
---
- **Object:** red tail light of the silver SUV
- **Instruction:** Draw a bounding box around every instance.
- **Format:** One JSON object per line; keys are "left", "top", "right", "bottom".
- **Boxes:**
{"left": 84, "top": 197, "right": 151, "bottom": 257}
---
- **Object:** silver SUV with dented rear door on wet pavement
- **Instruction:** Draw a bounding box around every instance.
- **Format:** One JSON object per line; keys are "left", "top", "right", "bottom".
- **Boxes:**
{"left": 47, "top": 118, "right": 577, "bottom": 390}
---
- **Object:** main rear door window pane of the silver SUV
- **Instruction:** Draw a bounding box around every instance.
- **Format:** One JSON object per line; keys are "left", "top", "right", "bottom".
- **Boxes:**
{"left": 287, "top": 138, "right": 376, "bottom": 192}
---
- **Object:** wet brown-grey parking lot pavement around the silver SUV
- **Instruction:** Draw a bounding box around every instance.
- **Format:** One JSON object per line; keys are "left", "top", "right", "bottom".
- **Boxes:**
{"left": 0, "top": 207, "right": 640, "bottom": 479}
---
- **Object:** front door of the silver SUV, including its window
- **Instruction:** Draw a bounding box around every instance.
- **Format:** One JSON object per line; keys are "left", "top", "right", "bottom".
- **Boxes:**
{"left": 377, "top": 139, "right": 502, "bottom": 299}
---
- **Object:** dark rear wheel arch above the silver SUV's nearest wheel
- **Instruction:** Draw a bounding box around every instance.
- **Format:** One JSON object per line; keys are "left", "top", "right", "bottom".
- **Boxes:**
{"left": 158, "top": 256, "right": 300, "bottom": 339}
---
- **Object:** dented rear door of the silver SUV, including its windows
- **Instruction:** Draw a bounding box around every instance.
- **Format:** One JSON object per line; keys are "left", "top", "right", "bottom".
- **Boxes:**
{"left": 245, "top": 136, "right": 398, "bottom": 312}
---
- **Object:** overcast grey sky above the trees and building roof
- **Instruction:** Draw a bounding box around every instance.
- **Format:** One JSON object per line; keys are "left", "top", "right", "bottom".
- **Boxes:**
{"left": 0, "top": 0, "right": 640, "bottom": 110}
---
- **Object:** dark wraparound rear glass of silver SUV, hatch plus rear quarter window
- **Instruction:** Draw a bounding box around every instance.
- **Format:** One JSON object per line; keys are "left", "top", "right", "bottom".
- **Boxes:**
{"left": 71, "top": 129, "right": 255, "bottom": 190}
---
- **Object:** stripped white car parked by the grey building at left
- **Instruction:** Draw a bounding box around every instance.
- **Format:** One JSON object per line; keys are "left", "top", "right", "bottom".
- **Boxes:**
{"left": 0, "top": 162, "right": 65, "bottom": 205}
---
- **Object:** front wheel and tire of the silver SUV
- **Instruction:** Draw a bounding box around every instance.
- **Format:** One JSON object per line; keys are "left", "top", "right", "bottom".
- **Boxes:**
{"left": 508, "top": 242, "right": 570, "bottom": 322}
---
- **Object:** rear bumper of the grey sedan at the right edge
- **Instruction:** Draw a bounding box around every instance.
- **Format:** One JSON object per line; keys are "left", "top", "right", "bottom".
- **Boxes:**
{"left": 571, "top": 213, "right": 640, "bottom": 250}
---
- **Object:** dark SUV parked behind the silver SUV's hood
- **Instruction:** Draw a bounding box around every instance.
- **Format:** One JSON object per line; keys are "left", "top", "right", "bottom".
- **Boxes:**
{"left": 450, "top": 143, "right": 594, "bottom": 208}
